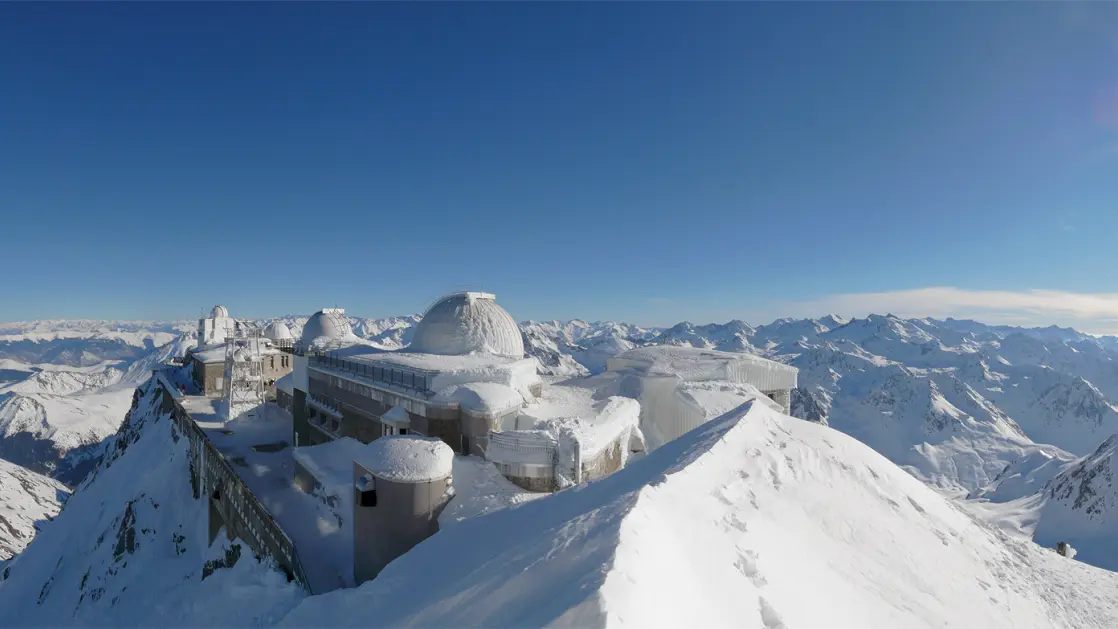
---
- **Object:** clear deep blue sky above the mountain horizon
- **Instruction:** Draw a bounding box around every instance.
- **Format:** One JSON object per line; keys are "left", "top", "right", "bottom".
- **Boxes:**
{"left": 0, "top": 3, "right": 1118, "bottom": 332}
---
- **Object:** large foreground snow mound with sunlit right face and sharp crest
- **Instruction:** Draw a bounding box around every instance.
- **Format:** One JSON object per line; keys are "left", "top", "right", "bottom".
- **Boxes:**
{"left": 281, "top": 404, "right": 1118, "bottom": 629}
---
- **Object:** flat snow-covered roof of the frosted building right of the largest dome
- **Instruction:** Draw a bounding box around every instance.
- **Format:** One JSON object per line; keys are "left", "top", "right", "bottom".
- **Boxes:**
{"left": 607, "top": 345, "right": 799, "bottom": 391}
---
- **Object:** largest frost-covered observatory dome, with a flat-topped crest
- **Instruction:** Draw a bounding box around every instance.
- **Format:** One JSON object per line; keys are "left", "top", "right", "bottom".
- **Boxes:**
{"left": 408, "top": 293, "right": 524, "bottom": 359}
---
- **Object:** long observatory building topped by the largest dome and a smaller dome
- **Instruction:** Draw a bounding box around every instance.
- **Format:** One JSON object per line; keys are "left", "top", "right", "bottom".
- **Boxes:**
{"left": 292, "top": 293, "right": 542, "bottom": 455}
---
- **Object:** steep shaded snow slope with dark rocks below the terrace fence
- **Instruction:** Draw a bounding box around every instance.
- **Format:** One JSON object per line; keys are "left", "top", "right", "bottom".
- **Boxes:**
{"left": 0, "top": 385, "right": 303, "bottom": 627}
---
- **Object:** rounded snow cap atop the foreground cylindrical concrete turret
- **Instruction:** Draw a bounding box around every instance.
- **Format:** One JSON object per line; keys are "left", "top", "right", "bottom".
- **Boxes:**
{"left": 353, "top": 435, "right": 454, "bottom": 483}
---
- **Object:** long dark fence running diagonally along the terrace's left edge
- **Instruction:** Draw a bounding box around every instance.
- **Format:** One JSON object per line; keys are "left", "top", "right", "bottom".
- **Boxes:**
{"left": 157, "top": 374, "right": 314, "bottom": 594}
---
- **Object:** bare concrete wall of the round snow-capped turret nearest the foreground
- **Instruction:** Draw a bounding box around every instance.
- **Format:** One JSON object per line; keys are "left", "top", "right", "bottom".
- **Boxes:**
{"left": 353, "top": 463, "right": 451, "bottom": 584}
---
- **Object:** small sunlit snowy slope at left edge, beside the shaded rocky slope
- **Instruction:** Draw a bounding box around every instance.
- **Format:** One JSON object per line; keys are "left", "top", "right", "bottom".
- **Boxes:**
{"left": 0, "top": 459, "right": 69, "bottom": 561}
